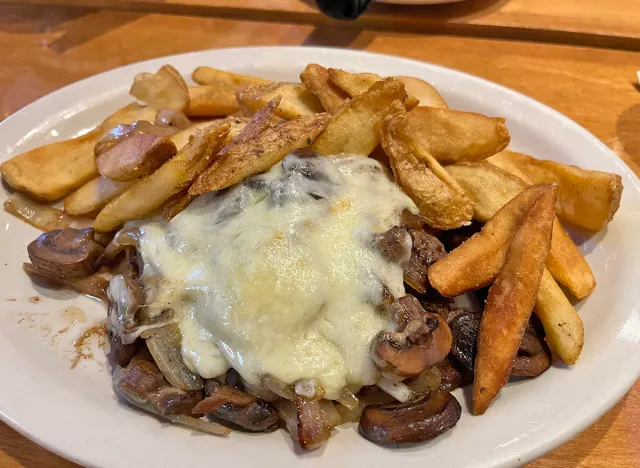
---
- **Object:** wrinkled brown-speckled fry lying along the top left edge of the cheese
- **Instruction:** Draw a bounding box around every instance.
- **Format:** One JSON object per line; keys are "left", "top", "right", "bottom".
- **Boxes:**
{"left": 189, "top": 113, "right": 331, "bottom": 196}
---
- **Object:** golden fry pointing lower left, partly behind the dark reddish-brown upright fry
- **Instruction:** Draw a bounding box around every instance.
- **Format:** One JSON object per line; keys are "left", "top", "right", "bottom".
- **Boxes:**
{"left": 429, "top": 185, "right": 549, "bottom": 297}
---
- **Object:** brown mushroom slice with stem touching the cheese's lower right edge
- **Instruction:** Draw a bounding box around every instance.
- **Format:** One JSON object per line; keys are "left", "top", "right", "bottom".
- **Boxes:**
{"left": 374, "top": 295, "right": 452, "bottom": 380}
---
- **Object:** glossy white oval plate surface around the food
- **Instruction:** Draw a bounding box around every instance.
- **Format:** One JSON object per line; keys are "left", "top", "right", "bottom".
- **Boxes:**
{"left": 0, "top": 47, "right": 640, "bottom": 468}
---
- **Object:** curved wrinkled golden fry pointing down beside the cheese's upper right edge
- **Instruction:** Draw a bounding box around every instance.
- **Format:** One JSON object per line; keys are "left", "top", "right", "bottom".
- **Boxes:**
{"left": 381, "top": 104, "right": 473, "bottom": 229}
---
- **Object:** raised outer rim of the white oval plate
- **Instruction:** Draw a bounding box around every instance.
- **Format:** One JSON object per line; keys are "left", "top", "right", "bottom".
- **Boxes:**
{"left": 0, "top": 46, "right": 640, "bottom": 466}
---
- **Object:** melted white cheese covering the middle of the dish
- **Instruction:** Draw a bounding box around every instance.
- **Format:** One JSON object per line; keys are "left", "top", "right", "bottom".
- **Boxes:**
{"left": 134, "top": 155, "right": 417, "bottom": 398}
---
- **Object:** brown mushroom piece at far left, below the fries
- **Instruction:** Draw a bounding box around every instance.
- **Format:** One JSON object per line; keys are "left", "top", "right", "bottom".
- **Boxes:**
{"left": 27, "top": 228, "right": 104, "bottom": 278}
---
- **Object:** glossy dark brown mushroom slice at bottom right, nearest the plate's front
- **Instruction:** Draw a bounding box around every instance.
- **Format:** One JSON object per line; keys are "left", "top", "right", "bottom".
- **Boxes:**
{"left": 358, "top": 392, "right": 462, "bottom": 445}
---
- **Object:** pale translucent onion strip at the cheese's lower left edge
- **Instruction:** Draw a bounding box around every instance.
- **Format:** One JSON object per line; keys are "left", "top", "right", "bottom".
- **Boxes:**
{"left": 146, "top": 323, "right": 204, "bottom": 390}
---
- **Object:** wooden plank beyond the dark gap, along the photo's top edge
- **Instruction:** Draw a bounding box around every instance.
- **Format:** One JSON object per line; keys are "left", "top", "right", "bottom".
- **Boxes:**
{"left": 7, "top": 0, "right": 640, "bottom": 50}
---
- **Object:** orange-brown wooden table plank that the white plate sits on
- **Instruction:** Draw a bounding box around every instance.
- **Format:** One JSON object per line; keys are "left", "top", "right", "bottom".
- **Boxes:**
{"left": 0, "top": 0, "right": 640, "bottom": 468}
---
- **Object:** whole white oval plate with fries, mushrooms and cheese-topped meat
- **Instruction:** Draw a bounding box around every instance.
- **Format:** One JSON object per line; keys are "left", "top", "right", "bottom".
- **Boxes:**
{"left": 0, "top": 47, "right": 640, "bottom": 467}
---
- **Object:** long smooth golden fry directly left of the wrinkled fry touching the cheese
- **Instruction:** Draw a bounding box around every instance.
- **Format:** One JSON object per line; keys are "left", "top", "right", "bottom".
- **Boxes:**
{"left": 93, "top": 123, "right": 230, "bottom": 232}
